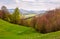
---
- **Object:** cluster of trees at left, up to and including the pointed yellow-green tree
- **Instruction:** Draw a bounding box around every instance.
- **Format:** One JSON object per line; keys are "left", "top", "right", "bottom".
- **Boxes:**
{"left": 0, "top": 6, "right": 21, "bottom": 24}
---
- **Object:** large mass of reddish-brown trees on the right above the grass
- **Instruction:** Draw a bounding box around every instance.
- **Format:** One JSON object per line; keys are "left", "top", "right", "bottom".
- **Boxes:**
{"left": 31, "top": 9, "right": 60, "bottom": 33}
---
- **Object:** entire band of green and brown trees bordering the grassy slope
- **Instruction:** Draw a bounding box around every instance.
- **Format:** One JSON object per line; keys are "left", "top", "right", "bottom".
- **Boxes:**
{"left": 0, "top": 6, "right": 60, "bottom": 33}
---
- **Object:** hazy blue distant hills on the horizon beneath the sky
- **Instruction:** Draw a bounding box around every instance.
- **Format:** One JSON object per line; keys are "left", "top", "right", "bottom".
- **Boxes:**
{"left": 8, "top": 9, "right": 45, "bottom": 15}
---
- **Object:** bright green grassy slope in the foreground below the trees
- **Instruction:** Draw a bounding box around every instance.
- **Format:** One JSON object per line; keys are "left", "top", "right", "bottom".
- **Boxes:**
{"left": 0, "top": 19, "right": 60, "bottom": 39}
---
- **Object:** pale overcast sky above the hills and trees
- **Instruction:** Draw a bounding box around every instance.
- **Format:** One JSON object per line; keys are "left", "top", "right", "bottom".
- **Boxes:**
{"left": 0, "top": 0, "right": 60, "bottom": 10}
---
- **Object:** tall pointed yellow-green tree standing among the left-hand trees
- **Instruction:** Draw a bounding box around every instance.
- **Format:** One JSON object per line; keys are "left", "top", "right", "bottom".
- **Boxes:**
{"left": 12, "top": 8, "right": 20, "bottom": 24}
